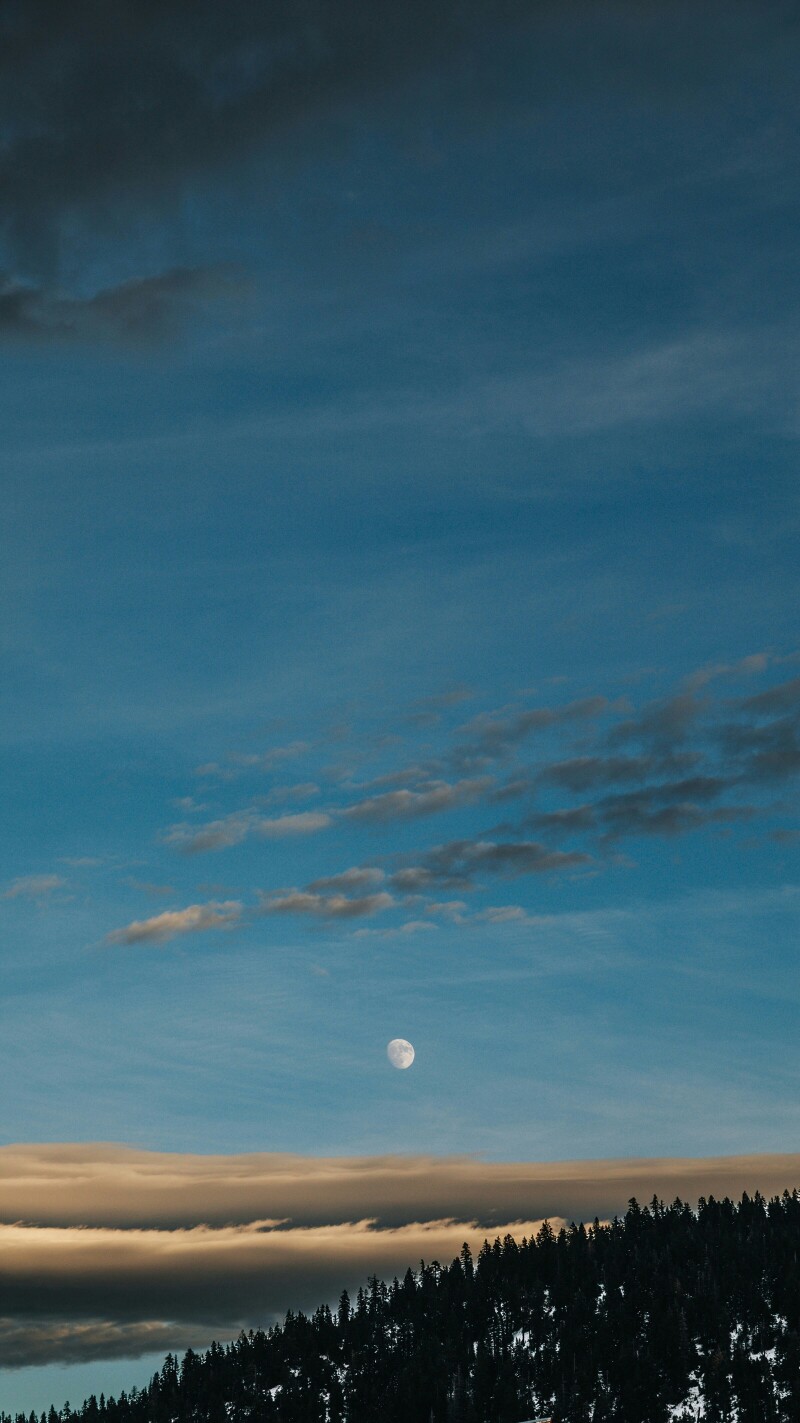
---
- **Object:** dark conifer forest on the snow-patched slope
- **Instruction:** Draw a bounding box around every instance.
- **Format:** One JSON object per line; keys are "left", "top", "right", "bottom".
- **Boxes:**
{"left": 9, "top": 1191, "right": 800, "bottom": 1423}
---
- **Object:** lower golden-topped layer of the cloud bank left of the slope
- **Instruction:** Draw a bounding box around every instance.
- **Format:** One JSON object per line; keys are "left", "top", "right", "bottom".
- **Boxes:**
{"left": 0, "top": 1217, "right": 541, "bottom": 1359}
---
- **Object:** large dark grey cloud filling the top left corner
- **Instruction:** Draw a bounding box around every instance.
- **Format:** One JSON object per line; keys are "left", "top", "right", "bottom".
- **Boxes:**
{"left": 0, "top": 0, "right": 531, "bottom": 273}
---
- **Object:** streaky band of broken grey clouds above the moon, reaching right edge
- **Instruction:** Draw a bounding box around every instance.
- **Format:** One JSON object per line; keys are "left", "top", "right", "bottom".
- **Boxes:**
{"left": 138, "top": 665, "right": 800, "bottom": 922}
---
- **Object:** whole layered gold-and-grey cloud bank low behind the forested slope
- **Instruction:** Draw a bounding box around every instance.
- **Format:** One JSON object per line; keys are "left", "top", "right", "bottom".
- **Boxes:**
{"left": 0, "top": 1144, "right": 800, "bottom": 1366}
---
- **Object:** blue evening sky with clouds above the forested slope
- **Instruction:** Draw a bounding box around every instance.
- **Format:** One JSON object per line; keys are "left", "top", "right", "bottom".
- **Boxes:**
{"left": 0, "top": 0, "right": 800, "bottom": 1409}
